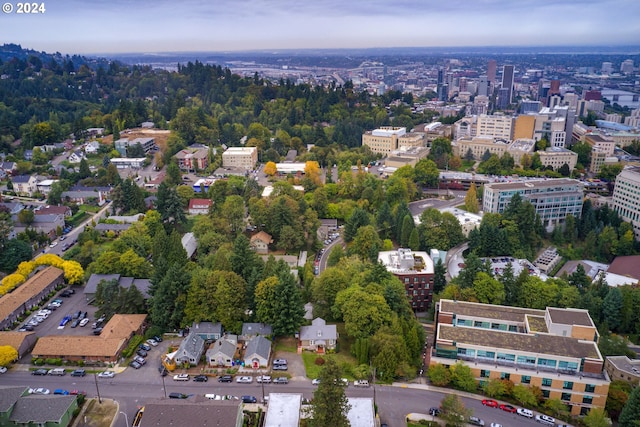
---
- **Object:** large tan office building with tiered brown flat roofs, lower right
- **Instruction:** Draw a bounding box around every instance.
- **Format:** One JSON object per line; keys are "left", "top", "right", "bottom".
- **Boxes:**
{"left": 430, "top": 299, "right": 610, "bottom": 415}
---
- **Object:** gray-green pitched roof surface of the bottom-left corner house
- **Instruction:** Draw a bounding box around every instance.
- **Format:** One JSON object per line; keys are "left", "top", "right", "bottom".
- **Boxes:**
{"left": 9, "top": 395, "right": 76, "bottom": 424}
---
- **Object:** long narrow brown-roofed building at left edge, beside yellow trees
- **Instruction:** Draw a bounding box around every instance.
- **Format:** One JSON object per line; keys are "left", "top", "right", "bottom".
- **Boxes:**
{"left": 0, "top": 267, "right": 64, "bottom": 329}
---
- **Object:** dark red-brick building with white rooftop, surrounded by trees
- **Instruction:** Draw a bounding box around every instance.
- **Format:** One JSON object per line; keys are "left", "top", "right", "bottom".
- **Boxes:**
{"left": 378, "top": 248, "right": 434, "bottom": 311}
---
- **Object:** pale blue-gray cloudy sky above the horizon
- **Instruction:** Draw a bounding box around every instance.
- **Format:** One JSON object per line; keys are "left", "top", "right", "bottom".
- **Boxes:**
{"left": 0, "top": 0, "right": 640, "bottom": 54}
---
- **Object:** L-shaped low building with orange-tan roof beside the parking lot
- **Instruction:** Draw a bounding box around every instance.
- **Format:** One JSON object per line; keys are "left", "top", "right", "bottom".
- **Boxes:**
{"left": 31, "top": 314, "right": 147, "bottom": 362}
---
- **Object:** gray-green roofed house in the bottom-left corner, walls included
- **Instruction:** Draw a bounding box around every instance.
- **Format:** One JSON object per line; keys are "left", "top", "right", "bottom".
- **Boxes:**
{"left": 9, "top": 394, "right": 78, "bottom": 427}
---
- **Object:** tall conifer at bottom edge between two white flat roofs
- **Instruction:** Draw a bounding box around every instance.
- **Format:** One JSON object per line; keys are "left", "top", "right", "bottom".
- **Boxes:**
{"left": 309, "top": 357, "right": 351, "bottom": 427}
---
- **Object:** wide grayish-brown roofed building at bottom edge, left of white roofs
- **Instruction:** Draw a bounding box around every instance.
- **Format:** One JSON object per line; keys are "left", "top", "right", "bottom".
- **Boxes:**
{"left": 141, "top": 396, "right": 244, "bottom": 427}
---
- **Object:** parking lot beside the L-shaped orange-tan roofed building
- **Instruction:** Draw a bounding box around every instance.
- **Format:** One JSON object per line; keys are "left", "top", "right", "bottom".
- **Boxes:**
{"left": 18, "top": 287, "right": 97, "bottom": 337}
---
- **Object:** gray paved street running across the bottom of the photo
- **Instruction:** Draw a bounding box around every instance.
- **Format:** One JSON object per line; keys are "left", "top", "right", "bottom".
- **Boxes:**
{"left": 2, "top": 372, "right": 552, "bottom": 427}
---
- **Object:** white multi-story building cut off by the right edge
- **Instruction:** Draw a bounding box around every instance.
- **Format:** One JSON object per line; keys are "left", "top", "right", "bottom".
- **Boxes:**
{"left": 613, "top": 167, "right": 640, "bottom": 239}
